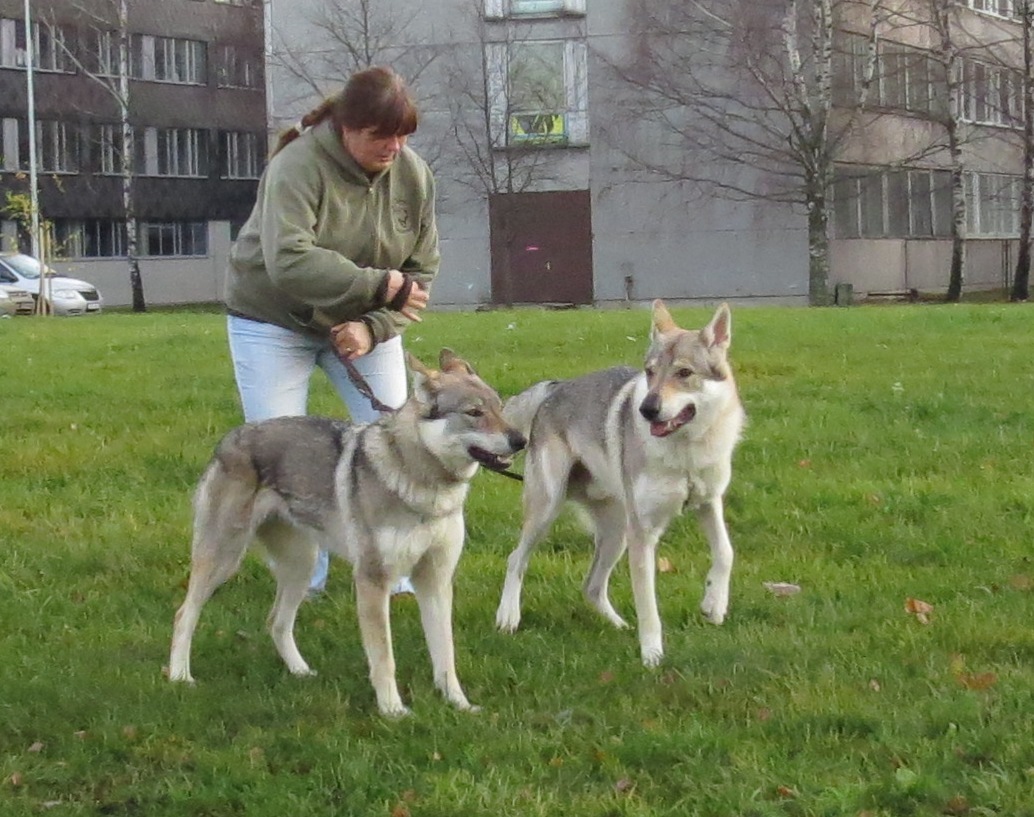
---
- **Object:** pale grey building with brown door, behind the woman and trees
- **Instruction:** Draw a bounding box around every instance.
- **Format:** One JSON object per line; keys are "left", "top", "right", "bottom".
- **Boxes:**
{"left": 269, "top": 0, "right": 1023, "bottom": 305}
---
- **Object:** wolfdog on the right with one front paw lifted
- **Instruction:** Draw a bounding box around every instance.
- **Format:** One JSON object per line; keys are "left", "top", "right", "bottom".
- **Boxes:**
{"left": 495, "top": 301, "right": 744, "bottom": 666}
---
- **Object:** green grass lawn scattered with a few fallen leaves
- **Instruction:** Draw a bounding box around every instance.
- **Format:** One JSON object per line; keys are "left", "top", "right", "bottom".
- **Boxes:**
{"left": 0, "top": 304, "right": 1034, "bottom": 817}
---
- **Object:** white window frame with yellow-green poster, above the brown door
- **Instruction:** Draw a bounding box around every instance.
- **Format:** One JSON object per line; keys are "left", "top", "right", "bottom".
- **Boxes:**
{"left": 485, "top": 39, "right": 588, "bottom": 148}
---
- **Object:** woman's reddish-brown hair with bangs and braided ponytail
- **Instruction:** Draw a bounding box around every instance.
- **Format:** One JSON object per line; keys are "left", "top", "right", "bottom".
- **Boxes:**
{"left": 270, "top": 66, "right": 420, "bottom": 156}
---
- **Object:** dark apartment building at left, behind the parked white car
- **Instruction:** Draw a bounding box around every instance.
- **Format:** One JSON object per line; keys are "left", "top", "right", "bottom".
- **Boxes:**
{"left": 0, "top": 0, "right": 267, "bottom": 305}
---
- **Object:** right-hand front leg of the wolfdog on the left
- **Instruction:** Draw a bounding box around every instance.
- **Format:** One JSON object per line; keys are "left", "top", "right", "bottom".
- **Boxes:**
{"left": 410, "top": 533, "right": 478, "bottom": 709}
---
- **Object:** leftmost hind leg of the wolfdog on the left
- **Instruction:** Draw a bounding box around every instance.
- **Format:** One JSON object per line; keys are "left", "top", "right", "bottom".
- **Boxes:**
{"left": 169, "top": 475, "right": 253, "bottom": 683}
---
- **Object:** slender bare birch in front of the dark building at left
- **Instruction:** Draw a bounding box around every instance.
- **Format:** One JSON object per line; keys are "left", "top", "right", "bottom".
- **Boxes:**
{"left": 49, "top": 0, "right": 147, "bottom": 312}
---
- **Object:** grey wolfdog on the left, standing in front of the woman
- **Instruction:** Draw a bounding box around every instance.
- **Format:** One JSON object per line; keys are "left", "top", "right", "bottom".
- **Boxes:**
{"left": 169, "top": 350, "right": 525, "bottom": 716}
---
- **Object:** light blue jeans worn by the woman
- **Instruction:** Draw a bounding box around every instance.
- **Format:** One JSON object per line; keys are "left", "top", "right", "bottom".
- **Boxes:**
{"left": 226, "top": 315, "right": 407, "bottom": 592}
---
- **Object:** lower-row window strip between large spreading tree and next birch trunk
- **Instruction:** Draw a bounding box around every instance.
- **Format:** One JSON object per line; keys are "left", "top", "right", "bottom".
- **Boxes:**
{"left": 833, "top": 169, "right": 951, "bottom": 238}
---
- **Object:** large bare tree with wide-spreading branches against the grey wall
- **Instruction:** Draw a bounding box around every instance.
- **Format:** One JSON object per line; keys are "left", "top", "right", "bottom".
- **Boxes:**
{"left": 605, "top": 0, "right": 881, "bottom": 305}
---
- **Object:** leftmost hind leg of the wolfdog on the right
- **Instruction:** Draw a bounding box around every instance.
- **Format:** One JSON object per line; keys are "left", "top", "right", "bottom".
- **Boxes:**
{"left": 495, "top": 446, "right": 572, "bottom": 633}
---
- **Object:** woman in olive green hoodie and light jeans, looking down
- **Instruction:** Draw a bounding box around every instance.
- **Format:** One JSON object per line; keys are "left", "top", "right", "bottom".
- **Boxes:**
{"left": 225, "top": 67, "right": 439, "bottom": 593}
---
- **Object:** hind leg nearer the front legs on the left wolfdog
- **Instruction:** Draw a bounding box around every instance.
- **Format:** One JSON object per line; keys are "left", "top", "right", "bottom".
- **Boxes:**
{"left": 259, "top": 520, "right": 318, "bottom": 675}
